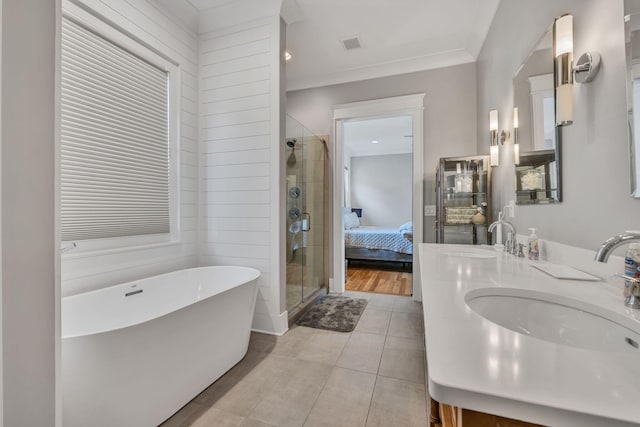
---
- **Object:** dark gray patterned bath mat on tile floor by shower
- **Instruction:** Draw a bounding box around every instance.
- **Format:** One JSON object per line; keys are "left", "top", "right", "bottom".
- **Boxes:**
{"left": 296, "top": 295, "right": 367, "bottom": 332}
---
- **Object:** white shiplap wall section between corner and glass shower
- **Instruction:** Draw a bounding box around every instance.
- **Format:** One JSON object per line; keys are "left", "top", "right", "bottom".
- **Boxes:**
{"left": 199, "top": 16, "right": 287, "bottom": 333}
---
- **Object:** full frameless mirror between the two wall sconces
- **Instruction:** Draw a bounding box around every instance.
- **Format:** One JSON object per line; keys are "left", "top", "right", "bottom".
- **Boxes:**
{"left": 513, "top": 27, "right": 561, "bottom": 205}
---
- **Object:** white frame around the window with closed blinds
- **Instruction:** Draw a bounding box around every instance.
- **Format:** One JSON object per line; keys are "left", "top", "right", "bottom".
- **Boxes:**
{"left": 57, "top": 2, "right": 181, "bottom": 257}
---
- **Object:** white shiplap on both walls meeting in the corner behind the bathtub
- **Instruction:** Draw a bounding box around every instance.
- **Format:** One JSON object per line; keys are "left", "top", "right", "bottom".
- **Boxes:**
{"left": 57, "top": 0, "right": 287, "bottom": 332}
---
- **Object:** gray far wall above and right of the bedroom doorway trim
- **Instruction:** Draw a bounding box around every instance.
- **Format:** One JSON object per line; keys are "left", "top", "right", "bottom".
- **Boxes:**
{"left": 287, "top": 64, "right": 478, "bottom": 242}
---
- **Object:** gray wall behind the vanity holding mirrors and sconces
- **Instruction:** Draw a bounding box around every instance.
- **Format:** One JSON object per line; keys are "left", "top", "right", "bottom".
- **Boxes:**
{"left": 477, "top": 0, "right": 640, "bottom": 251}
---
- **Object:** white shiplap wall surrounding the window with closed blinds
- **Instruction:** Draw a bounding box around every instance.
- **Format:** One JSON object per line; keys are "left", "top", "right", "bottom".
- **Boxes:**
{"left": 61, "top": 0, "right": 199, "bottom": 296}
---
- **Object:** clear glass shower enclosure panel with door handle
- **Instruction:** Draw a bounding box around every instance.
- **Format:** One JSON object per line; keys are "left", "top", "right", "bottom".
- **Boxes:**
{"left": 284, "top": 116, "right": 328, "bottom": 312}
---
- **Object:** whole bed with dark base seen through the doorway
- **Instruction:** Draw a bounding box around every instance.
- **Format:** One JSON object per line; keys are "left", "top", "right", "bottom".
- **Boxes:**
{"left": 344, "top": 213, "right": 413, "bottom": 266}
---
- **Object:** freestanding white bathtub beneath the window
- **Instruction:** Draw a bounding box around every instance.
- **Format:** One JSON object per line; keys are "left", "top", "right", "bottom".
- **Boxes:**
{"left": 62, "top": 267, "right": 260, "bottom": 427}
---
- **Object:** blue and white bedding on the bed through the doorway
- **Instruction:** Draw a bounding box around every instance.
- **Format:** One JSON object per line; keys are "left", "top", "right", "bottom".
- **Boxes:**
{"left": 344, "top": 226, "right": 413, "bottom": 254}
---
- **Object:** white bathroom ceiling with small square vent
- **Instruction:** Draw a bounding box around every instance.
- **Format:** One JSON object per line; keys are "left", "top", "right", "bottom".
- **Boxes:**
{"left": 180, "top": 0, "right": 500, "bottom": 91}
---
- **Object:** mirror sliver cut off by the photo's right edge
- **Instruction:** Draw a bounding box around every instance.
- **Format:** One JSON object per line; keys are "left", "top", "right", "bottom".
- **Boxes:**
{"left": 624, "top": 0, "right": 640, "bottom": 198}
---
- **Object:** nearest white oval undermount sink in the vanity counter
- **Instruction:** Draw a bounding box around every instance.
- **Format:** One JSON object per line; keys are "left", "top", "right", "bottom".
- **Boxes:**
{"left": 465, "top": 288, "right": 640, "bottom": 352}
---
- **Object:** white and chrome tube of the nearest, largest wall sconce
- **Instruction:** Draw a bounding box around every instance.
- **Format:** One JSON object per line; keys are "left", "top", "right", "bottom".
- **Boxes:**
{"left": 553, "top": 14, "right": 573, "bottom": 126}
